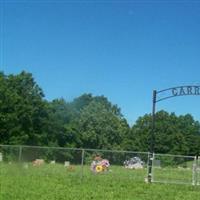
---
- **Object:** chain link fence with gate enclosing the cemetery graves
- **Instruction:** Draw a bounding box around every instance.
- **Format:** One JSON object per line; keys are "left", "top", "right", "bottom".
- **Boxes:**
{"left": 0, "top": 145, "right": 200, "bottom": 185}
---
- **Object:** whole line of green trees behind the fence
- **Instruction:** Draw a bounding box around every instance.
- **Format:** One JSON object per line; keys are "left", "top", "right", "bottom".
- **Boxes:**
{"left": 0, "top": 71, "right": 200, "bottom": 155}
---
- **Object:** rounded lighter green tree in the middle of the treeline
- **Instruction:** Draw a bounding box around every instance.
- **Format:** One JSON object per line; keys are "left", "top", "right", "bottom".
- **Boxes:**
{"left": 69, "top": 96, "right": 129, "bottom": 149}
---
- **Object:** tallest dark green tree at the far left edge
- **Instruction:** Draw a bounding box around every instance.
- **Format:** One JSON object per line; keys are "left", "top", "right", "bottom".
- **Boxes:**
{"left": 0, "top": 71, "right": 48, "bottom": 145}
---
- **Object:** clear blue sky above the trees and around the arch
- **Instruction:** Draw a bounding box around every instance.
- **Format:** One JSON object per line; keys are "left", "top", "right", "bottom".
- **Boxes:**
{"left": 0, "top": 0, "right": 200, "bottom": 124}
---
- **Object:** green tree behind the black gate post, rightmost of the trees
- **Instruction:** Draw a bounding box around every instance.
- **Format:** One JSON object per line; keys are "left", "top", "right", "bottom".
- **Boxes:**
{"left": 129, "top": 110, "right": 200, "bottom": 155}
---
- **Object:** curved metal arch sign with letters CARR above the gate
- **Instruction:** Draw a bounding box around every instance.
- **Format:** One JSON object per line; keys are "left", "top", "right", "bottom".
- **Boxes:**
{"left": 154, "top": 85, "right": 200, "bottom": 102}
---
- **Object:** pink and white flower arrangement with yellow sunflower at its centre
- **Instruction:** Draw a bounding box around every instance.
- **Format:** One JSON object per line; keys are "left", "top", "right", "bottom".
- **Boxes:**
{"left": 90, "top": 156, "right": 110, "bottom": 173}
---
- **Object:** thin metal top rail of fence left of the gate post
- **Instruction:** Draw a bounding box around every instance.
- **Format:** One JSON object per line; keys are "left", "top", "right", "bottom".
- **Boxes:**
{"left": 0, "top": 144, "right": 149, "bottom": 155}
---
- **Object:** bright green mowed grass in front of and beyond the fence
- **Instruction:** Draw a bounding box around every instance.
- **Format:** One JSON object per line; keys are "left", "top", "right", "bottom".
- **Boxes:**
{"left": 0, "top": 164, "right": 200, "bottom": 200}
